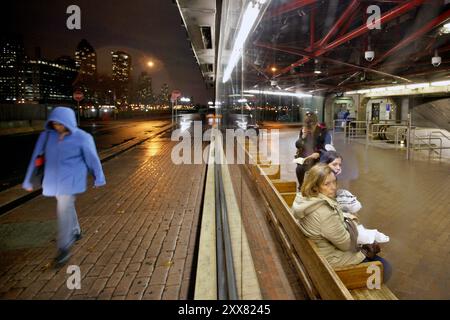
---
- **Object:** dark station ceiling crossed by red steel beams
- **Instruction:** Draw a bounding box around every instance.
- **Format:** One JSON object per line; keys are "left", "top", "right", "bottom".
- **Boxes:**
{"left": 236, "top": 0, "right": 450, "bottom": 93}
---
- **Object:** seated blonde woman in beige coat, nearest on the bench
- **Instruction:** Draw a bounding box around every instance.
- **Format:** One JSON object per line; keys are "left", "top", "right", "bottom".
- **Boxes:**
{"left": 293, "top": 163, "right": 390, "bottom": 281}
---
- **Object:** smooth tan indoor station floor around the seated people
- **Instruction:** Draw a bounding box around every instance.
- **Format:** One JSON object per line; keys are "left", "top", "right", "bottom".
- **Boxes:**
{"left": 272, "top": 128, "right": 450, "bottom": 299}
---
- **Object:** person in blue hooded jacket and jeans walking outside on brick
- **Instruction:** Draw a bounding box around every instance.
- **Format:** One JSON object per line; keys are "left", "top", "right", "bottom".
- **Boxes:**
{"left": 22, "top": 107, "right": 106, "bottom": 265}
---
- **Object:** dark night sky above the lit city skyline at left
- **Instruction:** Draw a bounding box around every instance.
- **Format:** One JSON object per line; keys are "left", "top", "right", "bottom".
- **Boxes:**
{"left": 1, "top": 0, "right": 213, "bottom": 104}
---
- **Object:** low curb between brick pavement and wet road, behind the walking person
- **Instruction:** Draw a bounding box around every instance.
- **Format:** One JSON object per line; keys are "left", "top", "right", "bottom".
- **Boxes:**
{"left": 0, "top": 124, "right": 174, "bottom": 216}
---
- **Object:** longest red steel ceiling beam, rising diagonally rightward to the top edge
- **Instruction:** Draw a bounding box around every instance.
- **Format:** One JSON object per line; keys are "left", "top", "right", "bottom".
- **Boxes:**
{"left": 275, "top": 0, "right": 425, "bottom": 77}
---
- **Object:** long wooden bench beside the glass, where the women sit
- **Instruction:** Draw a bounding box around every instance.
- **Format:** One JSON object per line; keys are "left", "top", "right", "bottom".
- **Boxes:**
{"left": 245, "top": 145, "right": 397, "bottom": 300}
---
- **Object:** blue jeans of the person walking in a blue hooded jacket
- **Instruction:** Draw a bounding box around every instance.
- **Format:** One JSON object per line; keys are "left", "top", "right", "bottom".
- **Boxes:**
{"left": 56, "top": 195, "right": 81, "bottom": 250}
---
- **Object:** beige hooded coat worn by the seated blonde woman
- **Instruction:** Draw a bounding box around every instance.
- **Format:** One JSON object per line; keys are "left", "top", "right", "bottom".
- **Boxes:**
{"left": 292, "top": 193, "right": 366, "bottom": 267}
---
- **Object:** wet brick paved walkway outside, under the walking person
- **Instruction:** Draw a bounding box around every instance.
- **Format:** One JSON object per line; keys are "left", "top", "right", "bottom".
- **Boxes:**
{"left": 0, "top": 131, "right": 205, "bottom": 299}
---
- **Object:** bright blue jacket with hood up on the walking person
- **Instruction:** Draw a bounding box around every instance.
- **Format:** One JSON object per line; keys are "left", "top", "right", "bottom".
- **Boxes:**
{"left": 22, "top": 107, "right": 106, "bottom": 196}
